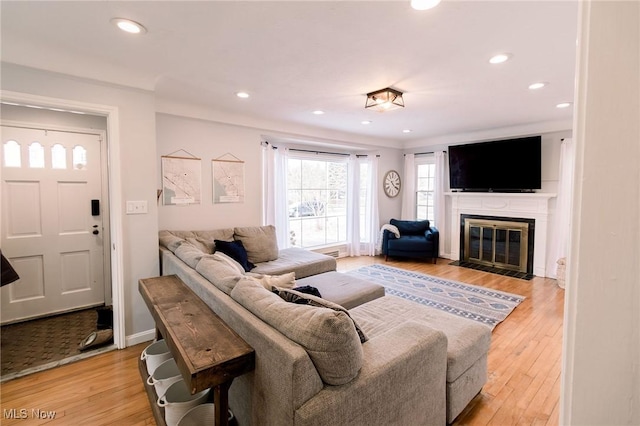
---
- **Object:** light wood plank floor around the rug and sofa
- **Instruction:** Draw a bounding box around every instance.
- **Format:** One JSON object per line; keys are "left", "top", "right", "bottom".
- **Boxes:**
{"left": 0, "top": 257, "right": 564, "bottom": 426}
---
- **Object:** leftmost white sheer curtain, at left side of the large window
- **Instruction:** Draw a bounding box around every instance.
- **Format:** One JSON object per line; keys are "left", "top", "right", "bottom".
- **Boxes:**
{"left": 262, "top": 143, "right": 289, "bottom": 249}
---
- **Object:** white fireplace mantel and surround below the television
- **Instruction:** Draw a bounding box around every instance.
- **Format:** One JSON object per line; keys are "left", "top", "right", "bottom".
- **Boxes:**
{"left": 445, "top": 192, "right": 556, "bottom": 277}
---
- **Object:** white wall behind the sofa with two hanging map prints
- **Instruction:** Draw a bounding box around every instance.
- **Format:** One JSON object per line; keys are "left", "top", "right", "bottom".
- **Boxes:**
{"left": 156, "top": 113, "right": 401, "bottom": 230}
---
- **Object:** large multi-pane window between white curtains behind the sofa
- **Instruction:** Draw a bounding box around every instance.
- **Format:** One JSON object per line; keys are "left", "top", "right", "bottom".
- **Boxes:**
{"left": 287, "top": 156, "right": 347, "bottom": 248}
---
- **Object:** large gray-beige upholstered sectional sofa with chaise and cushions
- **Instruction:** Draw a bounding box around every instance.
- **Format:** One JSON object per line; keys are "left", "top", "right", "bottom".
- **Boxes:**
{"left": 159, "top": 227, "right": 491, "bottom": 426}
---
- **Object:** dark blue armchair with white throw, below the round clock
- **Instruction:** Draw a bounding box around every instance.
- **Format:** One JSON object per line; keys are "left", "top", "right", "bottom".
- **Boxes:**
{"left": 382, "top": 219, "right": 440, "bottom": 263}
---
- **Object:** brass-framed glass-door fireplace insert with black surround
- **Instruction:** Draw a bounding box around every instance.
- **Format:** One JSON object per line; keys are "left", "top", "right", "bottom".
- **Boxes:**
{"left": 460, "top": 214, "right": 535, "bottom": 274}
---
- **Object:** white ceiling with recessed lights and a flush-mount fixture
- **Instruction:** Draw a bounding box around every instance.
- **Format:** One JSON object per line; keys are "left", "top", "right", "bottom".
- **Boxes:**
{"left": 1, "top": 0, "right": 578, "bottom": 147}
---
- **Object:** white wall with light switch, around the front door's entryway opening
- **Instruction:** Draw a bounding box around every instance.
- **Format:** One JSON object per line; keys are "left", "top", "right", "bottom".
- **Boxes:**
{"left": 1, "top": 63, "right": 159, "bottom": 336}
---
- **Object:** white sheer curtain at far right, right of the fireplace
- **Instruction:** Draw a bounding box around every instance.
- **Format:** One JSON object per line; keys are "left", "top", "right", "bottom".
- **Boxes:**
{"left": 547, "top": 139, "right": 575, "bottom": 288}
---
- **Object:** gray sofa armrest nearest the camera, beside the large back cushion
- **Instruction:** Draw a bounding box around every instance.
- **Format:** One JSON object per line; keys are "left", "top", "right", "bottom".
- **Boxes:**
{"left": 294, "top": 321, "right": 447, "bottom": 425}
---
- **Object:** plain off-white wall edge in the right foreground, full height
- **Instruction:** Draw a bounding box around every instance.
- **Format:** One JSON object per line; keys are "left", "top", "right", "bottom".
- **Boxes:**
{"left": 560, "top": 1, "right": 640, "bottom": 425}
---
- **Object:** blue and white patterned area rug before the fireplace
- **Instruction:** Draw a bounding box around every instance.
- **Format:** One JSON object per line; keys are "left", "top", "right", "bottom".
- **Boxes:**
{"left": 346, "top": 264, "right": 525, "bottom": 329}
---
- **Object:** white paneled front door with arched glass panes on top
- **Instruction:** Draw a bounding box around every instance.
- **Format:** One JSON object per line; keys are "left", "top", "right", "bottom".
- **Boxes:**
{"left": 0, "top": 126, "right": 107, "bottom": 323}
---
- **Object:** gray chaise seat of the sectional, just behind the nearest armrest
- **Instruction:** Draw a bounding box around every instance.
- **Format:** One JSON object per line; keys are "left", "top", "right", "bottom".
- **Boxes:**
{"left": 349, "top": 295, "right": 491, "bottom": 423}
